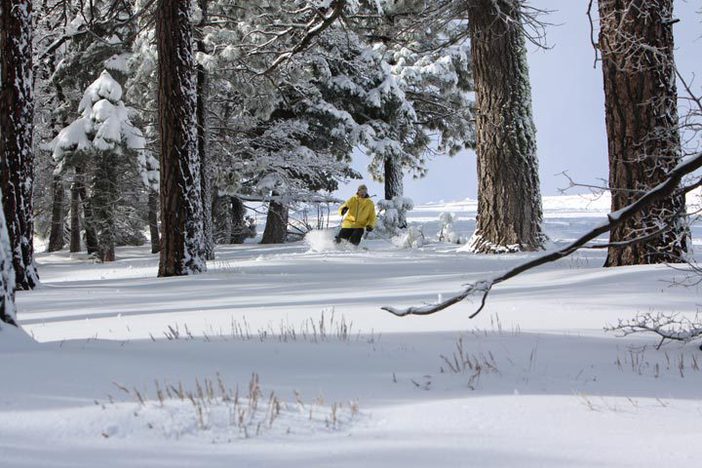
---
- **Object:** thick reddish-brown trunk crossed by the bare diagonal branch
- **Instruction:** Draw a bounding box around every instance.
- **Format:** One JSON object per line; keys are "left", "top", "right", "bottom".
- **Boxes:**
{"left": 599, "top": 0, "right": 688, "bottom": 266}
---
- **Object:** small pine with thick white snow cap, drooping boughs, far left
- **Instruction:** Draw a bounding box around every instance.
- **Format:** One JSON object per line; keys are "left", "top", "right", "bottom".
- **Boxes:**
{"left": 51, "top": 71, "right": 155, "bottom": 261}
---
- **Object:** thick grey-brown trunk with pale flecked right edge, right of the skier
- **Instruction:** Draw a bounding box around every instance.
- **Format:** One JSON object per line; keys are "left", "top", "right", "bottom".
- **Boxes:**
{"left": 468, "top": 0, "right": 544, "bottom": 253}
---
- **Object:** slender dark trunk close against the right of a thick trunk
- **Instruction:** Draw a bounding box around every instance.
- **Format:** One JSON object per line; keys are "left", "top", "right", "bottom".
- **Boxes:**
{"left": 197, "top": 0, "right": 215, "bottom": 260}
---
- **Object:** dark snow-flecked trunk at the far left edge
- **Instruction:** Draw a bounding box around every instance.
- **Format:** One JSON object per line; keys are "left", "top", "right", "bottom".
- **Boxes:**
{"left": 0, "top": 0, "right": 39, "bottom": 290}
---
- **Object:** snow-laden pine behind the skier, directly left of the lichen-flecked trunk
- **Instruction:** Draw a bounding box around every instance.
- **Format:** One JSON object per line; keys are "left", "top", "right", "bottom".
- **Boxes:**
{"left": 353, "top": 0, "right": 475, "bottom": 211}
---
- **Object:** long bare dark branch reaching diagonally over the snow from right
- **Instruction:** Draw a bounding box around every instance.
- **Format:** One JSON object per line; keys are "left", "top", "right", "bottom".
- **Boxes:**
{"left": 382, "top": 152, "right": 702, "bottom": 318}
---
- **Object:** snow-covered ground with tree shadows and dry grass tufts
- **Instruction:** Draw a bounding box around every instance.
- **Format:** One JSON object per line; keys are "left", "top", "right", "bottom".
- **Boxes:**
{"left": 0, "top": 196, "right": 702, "bottom": 468}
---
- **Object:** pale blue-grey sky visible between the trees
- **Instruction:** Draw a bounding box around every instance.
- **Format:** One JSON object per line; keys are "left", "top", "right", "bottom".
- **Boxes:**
{"left": 338, "top": 0, "right": 702, "bottom": 203}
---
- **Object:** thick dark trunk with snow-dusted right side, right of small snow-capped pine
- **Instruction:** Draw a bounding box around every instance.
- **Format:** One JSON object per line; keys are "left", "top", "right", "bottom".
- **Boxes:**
{"left": 157, "top": 0, "right": 207, "bottom": 276}
